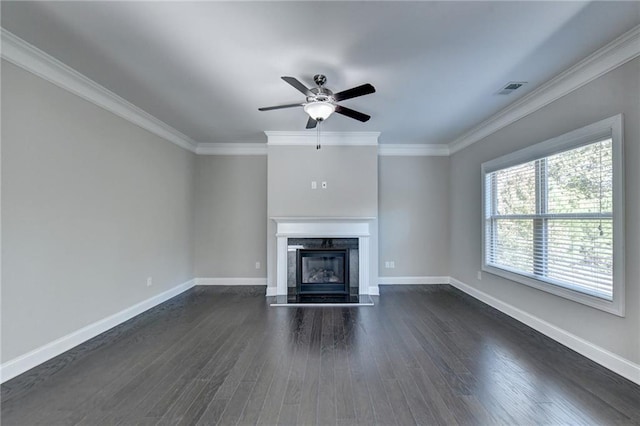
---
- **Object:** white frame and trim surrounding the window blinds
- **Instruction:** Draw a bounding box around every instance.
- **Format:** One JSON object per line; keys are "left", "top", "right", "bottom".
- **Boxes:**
{"left": 480, "top": 114, "right": 625, "bottom": 317}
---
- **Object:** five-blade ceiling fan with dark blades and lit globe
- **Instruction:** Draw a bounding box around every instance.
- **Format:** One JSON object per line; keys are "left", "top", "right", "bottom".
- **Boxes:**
{"left": 258, "top": 74, "right": 376, "bottom": 129}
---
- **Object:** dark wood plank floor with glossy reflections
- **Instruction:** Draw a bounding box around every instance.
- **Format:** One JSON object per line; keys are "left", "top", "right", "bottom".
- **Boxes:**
{"left": 2, "top": 286, "right": 640, "bottom": 425}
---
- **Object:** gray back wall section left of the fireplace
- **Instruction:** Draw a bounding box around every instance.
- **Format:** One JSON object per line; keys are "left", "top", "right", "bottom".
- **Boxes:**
{"left": 194, "top": 155, "right": 267, "bottom": 278}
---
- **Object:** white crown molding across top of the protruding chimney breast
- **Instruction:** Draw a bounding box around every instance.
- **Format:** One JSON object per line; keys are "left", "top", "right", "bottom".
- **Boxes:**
{"left": 264, "top": 130, "right": 380, "bottom": 146}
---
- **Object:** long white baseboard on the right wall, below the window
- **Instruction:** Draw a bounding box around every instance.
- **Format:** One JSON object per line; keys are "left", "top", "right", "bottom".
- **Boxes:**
{"left": 450, "top": 278, "right": 640, "bottom": 385}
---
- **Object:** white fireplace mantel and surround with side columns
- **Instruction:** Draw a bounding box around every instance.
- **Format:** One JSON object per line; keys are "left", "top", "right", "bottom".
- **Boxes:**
{"left": 271, "top": 217, "right": 375, "bottom": 296}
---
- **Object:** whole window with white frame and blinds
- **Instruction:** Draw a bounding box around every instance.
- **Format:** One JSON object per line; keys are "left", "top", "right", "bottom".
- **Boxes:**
{"left": 482, "top": 115, "right": 624, "bottom": 316}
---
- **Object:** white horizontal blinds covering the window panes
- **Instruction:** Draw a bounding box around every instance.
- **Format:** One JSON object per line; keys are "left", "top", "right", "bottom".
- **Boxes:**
{"left": 484, "top": 137, "right": 613, "bottom": 301}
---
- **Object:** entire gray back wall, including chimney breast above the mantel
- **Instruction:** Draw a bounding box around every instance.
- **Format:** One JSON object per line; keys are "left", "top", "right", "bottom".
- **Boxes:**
{"left": 194, "top": 147, "right": 449, "bottom": 288}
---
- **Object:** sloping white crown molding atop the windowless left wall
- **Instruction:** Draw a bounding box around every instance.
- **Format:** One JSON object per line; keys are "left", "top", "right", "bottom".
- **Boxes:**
{"left": 0, "top": 28, "right": 197, "bottom": 152}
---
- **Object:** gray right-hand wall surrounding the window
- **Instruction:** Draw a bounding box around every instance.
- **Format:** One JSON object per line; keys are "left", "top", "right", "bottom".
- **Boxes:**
{"left": 450, "top": 59, "right": 640, "bottom": 363}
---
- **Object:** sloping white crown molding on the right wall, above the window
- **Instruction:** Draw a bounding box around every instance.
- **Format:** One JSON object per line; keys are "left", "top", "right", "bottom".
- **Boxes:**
{"left": 449, "top": 25, "right": 640, "bottom": 154}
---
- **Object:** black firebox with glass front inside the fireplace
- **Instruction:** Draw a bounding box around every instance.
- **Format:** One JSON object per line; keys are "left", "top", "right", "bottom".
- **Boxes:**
{"left": 296, "top": 248, "right": 349, "bottom": 295}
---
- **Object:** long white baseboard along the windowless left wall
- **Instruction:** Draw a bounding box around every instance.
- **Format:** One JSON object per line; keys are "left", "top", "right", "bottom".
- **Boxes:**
{"left": 0, "top": 280, "right": 194, "bottom": 383}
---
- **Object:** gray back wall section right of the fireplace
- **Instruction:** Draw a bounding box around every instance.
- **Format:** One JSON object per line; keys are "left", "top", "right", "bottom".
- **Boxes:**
{"left": 378, "top": 157, "right": 449, "bottom": 277}
